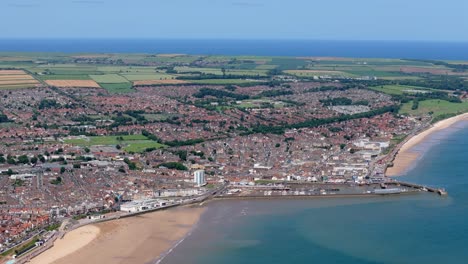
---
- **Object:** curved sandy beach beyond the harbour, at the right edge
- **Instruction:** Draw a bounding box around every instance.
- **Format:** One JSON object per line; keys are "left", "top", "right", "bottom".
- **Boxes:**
{"left": 385, "top": 113, "right": 468, "bottom": 177}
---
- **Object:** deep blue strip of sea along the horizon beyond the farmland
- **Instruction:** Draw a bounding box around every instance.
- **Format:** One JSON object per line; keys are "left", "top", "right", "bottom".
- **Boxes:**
{"left": 0, "top": 39, "right": 468, "bottom": 60}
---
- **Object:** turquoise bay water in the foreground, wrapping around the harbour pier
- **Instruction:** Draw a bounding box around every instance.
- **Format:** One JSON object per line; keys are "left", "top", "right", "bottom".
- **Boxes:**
{"left": 162, "top": 122, "right": 468, "bottom": 264}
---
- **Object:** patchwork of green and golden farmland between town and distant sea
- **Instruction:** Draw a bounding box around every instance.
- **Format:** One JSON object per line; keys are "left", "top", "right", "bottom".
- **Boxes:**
{"left": 0, "top": 53, "right": 468, "bottom": 94}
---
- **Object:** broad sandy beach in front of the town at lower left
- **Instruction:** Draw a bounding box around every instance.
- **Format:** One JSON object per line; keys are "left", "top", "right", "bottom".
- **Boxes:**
{"left": 30, "top": 207, "right": 204, "bottom": 264}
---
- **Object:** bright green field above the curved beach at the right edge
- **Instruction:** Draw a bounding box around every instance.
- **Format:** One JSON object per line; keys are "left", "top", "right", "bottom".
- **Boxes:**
{"left": 400, "top": 100, "right": 468, "bottom": 117}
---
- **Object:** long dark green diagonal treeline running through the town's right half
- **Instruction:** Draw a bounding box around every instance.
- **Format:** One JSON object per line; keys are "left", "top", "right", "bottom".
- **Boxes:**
{"left": 249, "top": 105, "right": 400, "bottom": 135}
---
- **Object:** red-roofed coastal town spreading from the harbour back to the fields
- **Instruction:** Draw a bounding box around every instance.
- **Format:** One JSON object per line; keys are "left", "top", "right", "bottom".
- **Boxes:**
{"left": 0, "top": 55, "right": 467, "bottom": 260}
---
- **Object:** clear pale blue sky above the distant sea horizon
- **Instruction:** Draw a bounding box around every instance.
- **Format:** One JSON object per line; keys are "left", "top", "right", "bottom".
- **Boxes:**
{"left": 0, "top": 0, "right": 468, "bottom": 41}
